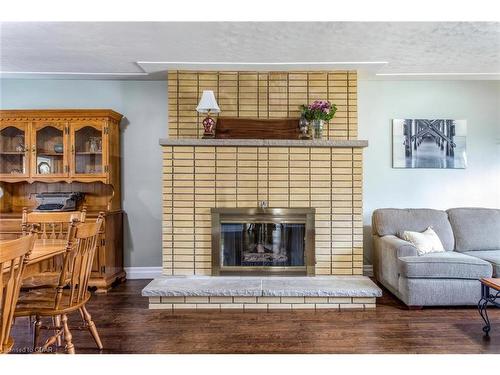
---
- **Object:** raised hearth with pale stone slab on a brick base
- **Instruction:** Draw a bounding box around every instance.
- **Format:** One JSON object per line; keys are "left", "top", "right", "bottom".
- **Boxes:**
{"left": 142, "top": 276, "right": 382, "bottom": 310}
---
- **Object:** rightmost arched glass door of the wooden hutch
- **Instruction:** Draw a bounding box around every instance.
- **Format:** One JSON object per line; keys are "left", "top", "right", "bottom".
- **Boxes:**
{"left": 71, "top": 123, "right": 106, "bottom": 176}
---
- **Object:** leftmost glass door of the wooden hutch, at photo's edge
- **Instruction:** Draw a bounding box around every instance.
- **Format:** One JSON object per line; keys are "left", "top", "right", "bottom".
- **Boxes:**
{"left": 0, "top": 123, "right": 29, "bottom": 177}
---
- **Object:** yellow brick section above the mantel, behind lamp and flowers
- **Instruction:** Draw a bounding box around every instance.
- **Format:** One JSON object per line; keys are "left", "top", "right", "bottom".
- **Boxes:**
{"left": 168, "top": 70, "right": 358, "bottom": 139}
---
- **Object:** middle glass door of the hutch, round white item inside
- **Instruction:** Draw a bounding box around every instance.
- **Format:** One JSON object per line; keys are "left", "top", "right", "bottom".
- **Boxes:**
{"left": 31, "top": 123, "right": 68, "bottom": 177}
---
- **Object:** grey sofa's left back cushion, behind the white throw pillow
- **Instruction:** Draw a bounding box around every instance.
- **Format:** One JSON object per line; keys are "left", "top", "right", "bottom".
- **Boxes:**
{"left": 372, "top": 208, "right": 455, "bottom": 250}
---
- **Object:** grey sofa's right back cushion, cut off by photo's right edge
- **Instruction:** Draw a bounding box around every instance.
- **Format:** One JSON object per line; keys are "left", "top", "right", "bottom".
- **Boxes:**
{"left": 447, "top": 208, "right": 500, "bottom": 252}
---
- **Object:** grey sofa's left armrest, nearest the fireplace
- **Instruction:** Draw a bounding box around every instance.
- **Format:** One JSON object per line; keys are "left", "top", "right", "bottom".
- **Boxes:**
{"left": 373, "top": 235, "right": 417, "bottom": 291}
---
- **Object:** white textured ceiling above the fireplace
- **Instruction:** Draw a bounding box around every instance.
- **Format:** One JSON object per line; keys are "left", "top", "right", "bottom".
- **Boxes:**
{"left": 0, "top": 22, "right": 500, "bottom": 77}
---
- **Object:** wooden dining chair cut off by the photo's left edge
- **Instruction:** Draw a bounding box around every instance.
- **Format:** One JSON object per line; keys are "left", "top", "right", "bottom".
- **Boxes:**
{"left": 0, "top": 233, "right": 35, "bottom": 353}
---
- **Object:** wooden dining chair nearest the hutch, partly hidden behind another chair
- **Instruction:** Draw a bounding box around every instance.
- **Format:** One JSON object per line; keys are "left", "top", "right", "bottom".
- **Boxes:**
{"left": 21, "top": 206, "right": 87, "bottom": 289}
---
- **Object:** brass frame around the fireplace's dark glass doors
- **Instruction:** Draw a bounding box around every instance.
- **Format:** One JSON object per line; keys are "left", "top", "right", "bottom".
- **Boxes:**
{"left": 211, "top": 208, "right": 316, "bottom": 276}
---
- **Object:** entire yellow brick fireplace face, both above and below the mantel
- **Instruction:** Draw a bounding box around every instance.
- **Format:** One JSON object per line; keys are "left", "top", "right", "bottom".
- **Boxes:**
{"left": 160, "top": 71, "right": 367, "bottom": 275}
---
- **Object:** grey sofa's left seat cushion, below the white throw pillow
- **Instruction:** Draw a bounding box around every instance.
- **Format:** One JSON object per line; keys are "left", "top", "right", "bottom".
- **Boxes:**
{"left": 398, "top": 251, "right": 492, "bottom": 279}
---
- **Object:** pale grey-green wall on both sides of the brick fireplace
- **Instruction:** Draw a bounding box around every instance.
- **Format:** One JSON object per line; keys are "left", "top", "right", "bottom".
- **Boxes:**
{"left": 0, "top": 79, "right": 500, "bottom": 267}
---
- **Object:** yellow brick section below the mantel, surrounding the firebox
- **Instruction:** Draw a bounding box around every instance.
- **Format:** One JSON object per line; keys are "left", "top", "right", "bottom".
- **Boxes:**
{"left": 163, "top": 146, "right": 363, "bottom": 275}
